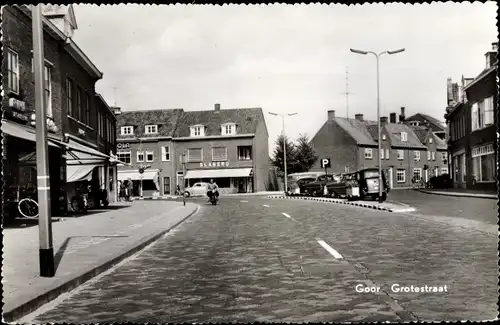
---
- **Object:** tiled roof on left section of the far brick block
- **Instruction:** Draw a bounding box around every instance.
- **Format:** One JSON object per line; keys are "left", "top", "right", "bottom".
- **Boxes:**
{"left": 116, "top": 109, "right": 183, "bottom": 139}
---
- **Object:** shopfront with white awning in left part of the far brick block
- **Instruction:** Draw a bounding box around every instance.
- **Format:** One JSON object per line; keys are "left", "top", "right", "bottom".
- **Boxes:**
{"left": 118, "top": 169, "right": 160, "bottom": 197}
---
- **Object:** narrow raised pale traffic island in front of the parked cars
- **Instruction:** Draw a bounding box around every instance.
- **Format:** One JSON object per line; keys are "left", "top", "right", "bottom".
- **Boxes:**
{"left": 268, "top": 195, "right": 416, "bottom": 212}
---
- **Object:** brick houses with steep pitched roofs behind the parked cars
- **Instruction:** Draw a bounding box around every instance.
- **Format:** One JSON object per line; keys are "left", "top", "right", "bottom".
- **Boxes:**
{"left": 311, "top": 110, "right": 446, "bottom": 188}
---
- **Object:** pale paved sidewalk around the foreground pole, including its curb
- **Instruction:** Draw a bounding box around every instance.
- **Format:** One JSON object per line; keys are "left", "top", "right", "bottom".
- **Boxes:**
{"left": 2, "top": 201, "right": 198, "bottom": 321}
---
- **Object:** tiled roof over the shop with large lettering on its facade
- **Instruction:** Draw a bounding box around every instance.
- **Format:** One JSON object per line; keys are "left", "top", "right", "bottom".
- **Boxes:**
{"left": 174, "top": 108, "right": 264, "bottom": 138}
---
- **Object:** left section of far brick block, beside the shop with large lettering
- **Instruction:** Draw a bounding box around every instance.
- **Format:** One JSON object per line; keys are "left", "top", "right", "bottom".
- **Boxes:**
{"left": 115, "top": 108, "right": 182, "bottom": 196}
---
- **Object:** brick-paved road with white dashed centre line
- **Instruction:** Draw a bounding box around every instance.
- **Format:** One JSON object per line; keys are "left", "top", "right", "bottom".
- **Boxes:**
{"left": 21, "top": 197, "right": 498, "bottom": 323}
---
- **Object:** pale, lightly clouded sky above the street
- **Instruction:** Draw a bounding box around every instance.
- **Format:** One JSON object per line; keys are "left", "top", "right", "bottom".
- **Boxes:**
{"left": 70, "top": 2, "right": 498, "bottom": 152}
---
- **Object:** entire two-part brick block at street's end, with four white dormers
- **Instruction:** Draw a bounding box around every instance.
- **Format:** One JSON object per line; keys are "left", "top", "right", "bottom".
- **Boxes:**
{"left": 114, "top": 104, "right": 269, "bottom": 196}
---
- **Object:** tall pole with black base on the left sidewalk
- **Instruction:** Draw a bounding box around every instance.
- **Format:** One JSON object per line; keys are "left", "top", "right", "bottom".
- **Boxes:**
{"left": 31, "top": 4, "right": 55, "bottom": 278}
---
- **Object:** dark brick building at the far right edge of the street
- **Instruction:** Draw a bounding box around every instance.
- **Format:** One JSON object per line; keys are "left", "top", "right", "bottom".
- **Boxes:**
{"left": 445, "top": 42, "right": 498, "bottom": 191}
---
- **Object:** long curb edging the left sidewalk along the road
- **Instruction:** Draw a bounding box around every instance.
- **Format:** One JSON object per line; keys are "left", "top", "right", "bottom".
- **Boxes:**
{"left": 3, "top": 205, "right": 200, "bottom": 323}
